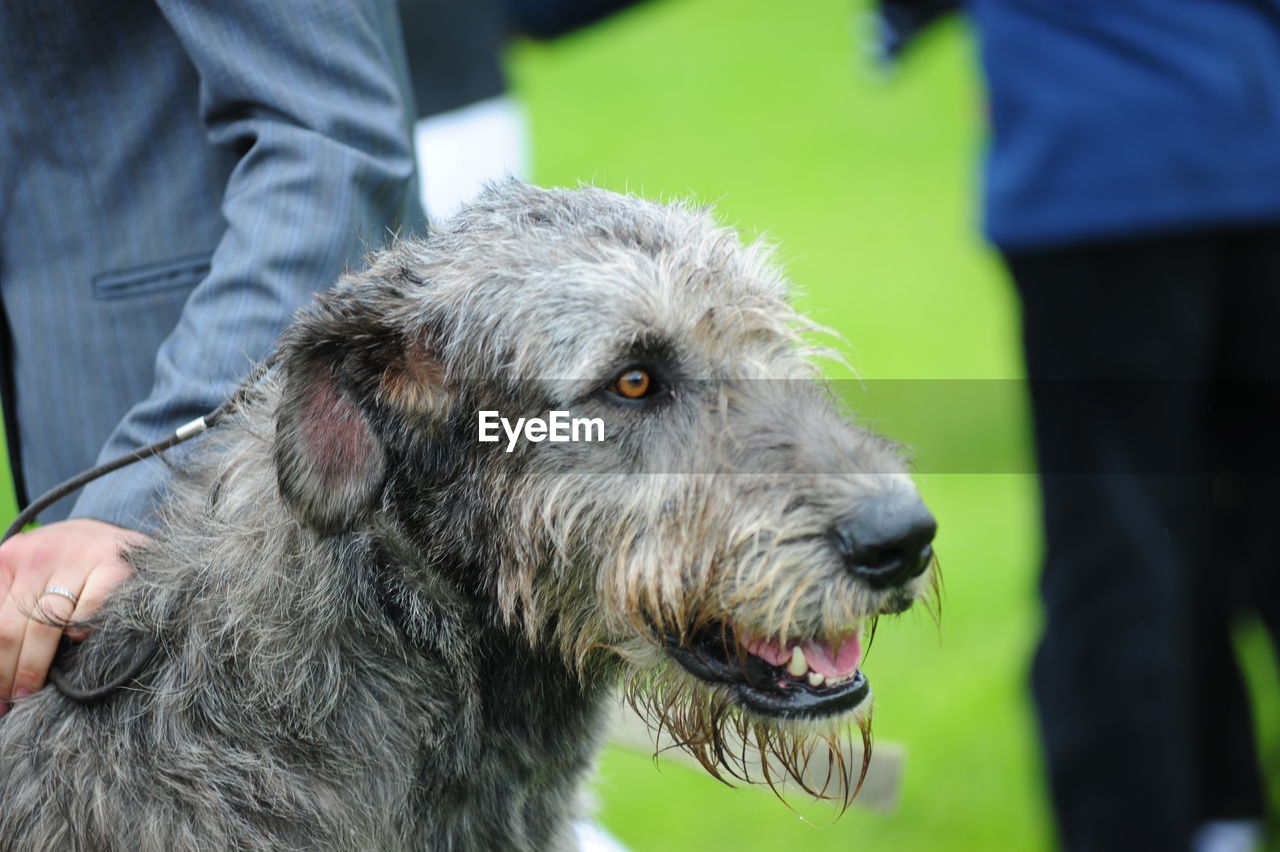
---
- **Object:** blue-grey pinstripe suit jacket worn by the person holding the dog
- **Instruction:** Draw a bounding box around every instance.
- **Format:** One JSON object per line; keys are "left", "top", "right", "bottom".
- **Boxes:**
{"left": 0, "top": 0, "right": 416, "bottom": 528}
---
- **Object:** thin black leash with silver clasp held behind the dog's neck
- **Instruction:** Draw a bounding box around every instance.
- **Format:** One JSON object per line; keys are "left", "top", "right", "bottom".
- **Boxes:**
{"left": 0, "top": 356, "right": 275, "bottom": 704}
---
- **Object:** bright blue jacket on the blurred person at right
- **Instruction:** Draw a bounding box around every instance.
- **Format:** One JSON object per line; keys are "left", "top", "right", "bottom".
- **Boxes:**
{"left": 969, "top": 0, "right": 1280, "bottom": 249}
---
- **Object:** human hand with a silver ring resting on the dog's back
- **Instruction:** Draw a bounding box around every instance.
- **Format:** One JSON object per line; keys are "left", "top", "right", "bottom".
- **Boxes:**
{"left": 0, "top": 518, "right": 150, "bottom": 715}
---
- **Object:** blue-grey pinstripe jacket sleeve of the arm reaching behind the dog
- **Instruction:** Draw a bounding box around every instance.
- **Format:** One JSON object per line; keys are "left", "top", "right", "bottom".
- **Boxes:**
{"left": 72, "top": 0, "right": 413, "bottom": 530}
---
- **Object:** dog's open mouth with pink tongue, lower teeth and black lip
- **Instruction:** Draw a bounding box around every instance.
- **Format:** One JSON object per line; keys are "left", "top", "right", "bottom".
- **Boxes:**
{"left": 667, "top": 624, "right": 870, "bottom": 719}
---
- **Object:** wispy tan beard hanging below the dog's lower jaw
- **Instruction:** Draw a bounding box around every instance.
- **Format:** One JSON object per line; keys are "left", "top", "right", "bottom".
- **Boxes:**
{"left": 622, "top": 664, "right": 872, "bottom": 814}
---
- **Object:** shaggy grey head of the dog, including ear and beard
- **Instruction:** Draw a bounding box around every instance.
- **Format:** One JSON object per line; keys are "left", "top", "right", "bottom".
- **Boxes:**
{"left": 275, "top": 182, "right": 934, "bottom": 796}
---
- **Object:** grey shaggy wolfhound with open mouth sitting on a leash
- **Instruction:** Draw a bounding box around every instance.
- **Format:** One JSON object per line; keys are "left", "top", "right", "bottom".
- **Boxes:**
{"left": 0, "top": 180, "right": 934, "bottom": 852}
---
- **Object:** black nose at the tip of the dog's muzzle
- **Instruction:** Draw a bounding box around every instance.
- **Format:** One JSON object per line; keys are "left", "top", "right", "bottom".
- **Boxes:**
{"left": 832, "top": 494, "right": 938, "bottom": 588}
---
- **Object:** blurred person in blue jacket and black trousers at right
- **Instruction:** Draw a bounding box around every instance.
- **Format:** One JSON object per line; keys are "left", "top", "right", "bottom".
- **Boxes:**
{"left": 878, "top": 0, "right": 1280, "bottom": 852}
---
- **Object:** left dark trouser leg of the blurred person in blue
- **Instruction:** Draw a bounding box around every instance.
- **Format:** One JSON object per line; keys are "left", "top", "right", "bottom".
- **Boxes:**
{"left": 1007, "top": 234, "right": 1269, "bottom": 849}
